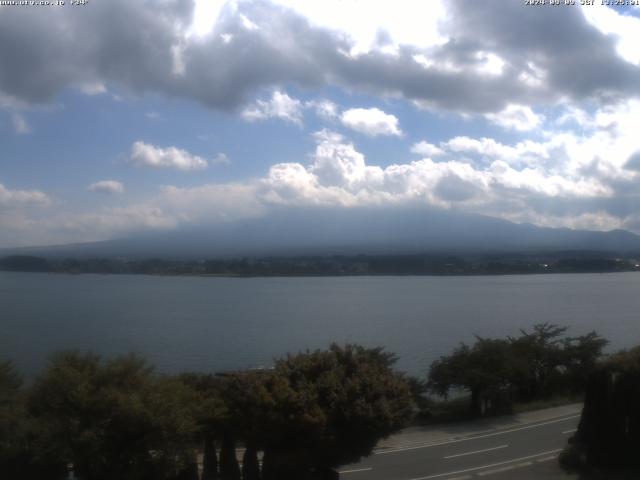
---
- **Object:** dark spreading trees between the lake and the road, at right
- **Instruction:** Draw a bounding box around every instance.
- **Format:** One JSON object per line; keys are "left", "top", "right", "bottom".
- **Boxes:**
{"left": 428, "top": 323, "right": 607, "bottom": 415}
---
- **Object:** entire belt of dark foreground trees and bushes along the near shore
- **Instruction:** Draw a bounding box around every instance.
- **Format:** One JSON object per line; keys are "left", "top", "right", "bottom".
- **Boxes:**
{"left": 0, "top": 323, "right": 640, "bottom": 480}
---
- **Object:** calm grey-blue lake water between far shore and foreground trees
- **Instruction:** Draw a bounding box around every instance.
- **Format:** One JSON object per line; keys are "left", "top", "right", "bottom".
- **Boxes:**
{"left": 0, "top": 272, "right": 640, "bottom": 374}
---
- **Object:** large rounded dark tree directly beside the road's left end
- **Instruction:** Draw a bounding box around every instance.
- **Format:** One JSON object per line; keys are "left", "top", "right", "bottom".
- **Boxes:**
{"left": 261, "top": 344, "right": 412, "bottom": 480}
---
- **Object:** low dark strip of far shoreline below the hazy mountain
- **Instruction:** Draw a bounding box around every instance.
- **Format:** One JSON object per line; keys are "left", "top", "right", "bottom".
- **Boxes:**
{"left": 0, "top": 252, "right": 640, "bottom": 277}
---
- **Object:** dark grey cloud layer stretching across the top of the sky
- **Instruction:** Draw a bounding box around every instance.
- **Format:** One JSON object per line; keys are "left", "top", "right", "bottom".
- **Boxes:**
{"left": 0, "top": 0, "right": 640, "bottom": 112}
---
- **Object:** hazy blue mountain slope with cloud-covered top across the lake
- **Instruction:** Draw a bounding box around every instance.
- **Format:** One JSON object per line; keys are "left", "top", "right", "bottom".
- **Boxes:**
{"left": 0, "top": 208, "right": 640, "bottom": 259}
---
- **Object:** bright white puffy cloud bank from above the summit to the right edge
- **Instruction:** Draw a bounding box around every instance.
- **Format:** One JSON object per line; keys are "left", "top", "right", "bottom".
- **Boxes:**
{"left": 255, "top": 111, "right": 640, "bottom": 228}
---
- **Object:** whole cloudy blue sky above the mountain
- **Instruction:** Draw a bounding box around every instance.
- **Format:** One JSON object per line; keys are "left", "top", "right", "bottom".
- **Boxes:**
{"left": 0, "top": 0, "right": 640, "bottom": 247}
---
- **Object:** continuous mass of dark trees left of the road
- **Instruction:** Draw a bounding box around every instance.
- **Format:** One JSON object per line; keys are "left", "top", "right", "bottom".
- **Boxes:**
{"left": 0, "top": 345, "right": 412, "bottom": 480}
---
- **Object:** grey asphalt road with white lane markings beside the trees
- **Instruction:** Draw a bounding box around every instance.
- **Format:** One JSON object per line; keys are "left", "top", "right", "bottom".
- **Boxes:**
{"left": 340, "top": 404, "right": 580, "bottom": 480}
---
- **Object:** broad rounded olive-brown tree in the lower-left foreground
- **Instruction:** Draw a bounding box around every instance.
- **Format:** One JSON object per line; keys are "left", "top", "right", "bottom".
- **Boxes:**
{"left": 29, "top": 352, "right": 201, "bottom": 480}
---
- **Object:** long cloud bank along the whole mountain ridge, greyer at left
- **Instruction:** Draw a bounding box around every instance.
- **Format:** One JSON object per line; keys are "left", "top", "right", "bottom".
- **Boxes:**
{"left": 10, "top": 101, "right": 640, "bottom": 246}
